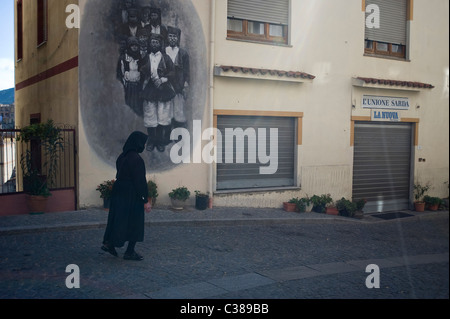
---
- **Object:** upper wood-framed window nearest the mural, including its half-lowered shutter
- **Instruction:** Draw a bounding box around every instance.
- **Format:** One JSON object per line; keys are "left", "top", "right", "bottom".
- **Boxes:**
{"left": 227, "top": 0, "right": 289, "bottom": 44}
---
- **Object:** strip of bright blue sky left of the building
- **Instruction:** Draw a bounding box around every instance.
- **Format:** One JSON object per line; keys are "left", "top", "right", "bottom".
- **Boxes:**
{"left": 0, "top": 0, "right": 14, "bottom": 90}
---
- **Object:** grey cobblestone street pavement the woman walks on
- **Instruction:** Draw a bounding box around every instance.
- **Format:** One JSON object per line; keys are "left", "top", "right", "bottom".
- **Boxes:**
{"left": 0, "top": 211, "right": 449, "bottom": 310}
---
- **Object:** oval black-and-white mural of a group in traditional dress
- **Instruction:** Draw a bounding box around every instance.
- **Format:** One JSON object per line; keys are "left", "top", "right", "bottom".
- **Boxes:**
{"left": 79, "top": 0, "right": 207, "bottom": 172}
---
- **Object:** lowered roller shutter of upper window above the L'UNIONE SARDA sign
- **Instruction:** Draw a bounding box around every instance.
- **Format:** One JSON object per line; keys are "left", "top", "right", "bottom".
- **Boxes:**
{"left": 365, "top": 0, "right": 407, "bottom": 45}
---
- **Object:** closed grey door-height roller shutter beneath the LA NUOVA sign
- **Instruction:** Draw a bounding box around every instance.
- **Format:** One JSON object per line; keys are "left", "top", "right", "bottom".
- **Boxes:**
{"left": 352, "top": 122, "right": 412, "bottom": 213}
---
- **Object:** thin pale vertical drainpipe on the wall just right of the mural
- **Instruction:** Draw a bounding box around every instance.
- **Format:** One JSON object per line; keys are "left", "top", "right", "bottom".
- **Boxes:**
{"left": 209, "top": 0, "right": 216, "bottom": 208}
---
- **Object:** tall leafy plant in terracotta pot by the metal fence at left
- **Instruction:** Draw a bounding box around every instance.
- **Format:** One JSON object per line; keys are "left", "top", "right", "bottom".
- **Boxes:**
{"left": 17, "top": 120, "right": 64, "bottom": 213}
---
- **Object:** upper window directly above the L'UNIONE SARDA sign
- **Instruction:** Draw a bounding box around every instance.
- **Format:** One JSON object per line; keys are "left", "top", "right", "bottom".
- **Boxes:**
{"left": 364, "top": 0, "right": 408, "bottom": 58}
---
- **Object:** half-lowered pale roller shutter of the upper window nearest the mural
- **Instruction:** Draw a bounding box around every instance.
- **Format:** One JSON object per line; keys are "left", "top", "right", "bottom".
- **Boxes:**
{"left": 228, "top": 0, "right": 289, "bottom": 25}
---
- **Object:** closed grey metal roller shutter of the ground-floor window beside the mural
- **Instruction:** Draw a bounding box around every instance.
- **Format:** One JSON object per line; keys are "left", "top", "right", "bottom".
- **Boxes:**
{"left": 217, "top": 115, "right": 296, "bottom": 190}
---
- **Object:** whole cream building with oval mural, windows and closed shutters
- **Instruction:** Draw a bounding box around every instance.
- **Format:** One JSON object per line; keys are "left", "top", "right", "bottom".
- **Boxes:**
{"left": 15, "top": 0, "right": 449, "bottom": 212}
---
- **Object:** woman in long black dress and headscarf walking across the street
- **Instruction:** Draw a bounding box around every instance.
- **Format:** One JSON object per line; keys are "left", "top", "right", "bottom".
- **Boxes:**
{"left": 102, "top": 131, "right": 151, "bottom": 260}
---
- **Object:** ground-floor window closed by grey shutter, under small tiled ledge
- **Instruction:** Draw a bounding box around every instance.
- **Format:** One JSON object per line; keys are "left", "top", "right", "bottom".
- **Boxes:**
{"left": 216, "top": 115, "right": 297, "bottom": 191}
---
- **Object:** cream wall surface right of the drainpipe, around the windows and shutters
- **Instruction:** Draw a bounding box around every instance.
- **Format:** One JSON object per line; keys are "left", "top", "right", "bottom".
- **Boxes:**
{"left": 214, "top": 0, "right": 449, "bottom": 206}
